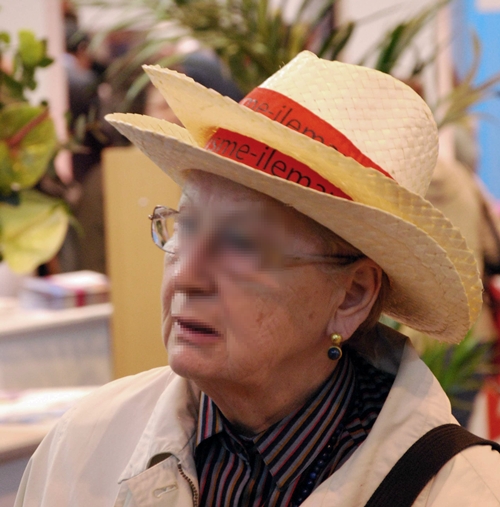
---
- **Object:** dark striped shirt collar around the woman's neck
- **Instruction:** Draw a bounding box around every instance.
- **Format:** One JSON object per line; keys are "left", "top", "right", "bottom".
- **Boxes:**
{"left": 196, "top": 354, "right": 355, "bottom": 489}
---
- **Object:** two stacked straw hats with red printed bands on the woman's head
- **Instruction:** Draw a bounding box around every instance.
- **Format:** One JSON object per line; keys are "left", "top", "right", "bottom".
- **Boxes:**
{"left": 106, "top": 52, "right": 482, "bottom": 342}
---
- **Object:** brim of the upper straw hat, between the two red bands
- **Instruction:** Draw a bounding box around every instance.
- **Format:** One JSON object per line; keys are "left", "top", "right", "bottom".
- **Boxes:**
{"left": 140, "top": 66, "right": 482, "bottom": 325}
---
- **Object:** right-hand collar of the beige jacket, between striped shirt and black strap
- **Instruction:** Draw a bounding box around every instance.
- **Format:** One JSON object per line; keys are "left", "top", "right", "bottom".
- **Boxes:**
{"left": 304, "top": 328, "right": 456, "bottom": 507}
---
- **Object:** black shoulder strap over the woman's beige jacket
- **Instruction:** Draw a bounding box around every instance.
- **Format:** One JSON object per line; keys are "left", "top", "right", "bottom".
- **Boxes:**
{"left": 365, "top": 424, "right": 500, "bottom": 507}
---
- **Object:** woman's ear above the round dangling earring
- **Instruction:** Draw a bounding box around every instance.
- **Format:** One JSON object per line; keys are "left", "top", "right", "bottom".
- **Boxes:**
{"left": 328, "top": 259, "right": 382, "bottom": 340}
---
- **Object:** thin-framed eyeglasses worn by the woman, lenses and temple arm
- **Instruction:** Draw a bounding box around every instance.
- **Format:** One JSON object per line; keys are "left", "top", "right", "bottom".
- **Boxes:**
{"left": 149, "top": 206, "right": 365, "bottom": 274}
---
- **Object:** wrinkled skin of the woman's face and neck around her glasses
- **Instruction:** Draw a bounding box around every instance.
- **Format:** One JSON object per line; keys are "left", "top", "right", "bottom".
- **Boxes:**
{"left": 162, "top": 171, "right": 379, "bottom": 433}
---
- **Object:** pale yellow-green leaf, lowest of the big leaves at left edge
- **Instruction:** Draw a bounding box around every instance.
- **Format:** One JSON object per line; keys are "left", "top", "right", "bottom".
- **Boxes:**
{"left": 0, "top": 190, "right": 68, "bottom": 273}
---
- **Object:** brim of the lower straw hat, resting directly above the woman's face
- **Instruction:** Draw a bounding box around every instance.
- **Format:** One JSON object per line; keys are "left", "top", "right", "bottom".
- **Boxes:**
{"left": 106, "top": 113, "right": 481, "bottom": 342}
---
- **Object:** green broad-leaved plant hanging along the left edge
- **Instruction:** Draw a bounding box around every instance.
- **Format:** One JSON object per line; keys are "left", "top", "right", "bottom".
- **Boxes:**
{"left": 0, "top": 30, "right": 69, "bottom": 274}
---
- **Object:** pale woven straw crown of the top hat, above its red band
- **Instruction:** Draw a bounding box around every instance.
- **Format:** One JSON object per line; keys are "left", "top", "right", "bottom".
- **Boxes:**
{"left": 260, "top": 51, "right": 438, "bottom": 196}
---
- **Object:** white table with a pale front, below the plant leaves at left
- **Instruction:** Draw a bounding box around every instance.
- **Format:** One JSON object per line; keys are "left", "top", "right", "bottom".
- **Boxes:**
{"left": 0, "top": 300, "right": 112, "bottom": 389}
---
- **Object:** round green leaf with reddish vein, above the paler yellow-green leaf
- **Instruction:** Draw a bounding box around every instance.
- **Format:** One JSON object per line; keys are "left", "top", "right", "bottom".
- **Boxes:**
{"left": 0, "top": 103, "right": 57, "bottom": 194}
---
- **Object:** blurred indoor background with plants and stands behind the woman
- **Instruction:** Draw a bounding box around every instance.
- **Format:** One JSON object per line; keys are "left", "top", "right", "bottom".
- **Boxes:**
{"left": 0, "top": 0, "right": 500, "bottom": 507}
